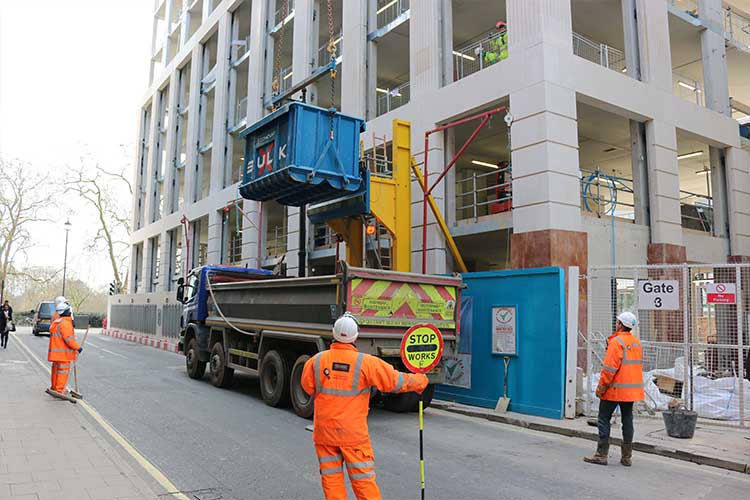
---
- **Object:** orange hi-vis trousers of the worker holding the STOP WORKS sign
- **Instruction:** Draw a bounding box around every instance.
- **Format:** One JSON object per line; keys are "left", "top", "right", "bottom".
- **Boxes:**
{"left": 315, "top": 443, "right": 382, "bottom": 500}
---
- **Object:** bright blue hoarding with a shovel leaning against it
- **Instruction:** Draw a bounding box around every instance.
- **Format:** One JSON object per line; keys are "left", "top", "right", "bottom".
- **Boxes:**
{"left": 436, "top": 267, "right": 566, "bottom": 418}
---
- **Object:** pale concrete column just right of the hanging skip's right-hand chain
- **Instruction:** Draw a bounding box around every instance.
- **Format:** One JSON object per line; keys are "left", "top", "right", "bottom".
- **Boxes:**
{"left": 341, "top": 1, "right": 368, "bottom": 117}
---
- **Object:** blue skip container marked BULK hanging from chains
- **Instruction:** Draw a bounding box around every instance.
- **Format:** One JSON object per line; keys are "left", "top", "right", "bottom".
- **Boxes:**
{"left": 240, "top": 102, "right": 368, "bottom": 207}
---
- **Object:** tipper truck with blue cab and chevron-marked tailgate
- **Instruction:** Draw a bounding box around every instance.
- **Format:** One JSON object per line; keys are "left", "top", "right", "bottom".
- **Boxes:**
{"left": 177, "top": 262, "right": 462, "bottom": 418}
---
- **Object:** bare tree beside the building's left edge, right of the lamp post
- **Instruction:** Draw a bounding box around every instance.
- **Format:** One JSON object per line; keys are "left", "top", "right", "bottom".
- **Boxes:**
{"left": 65, "top": 154, "right": 133, "bottom": 289}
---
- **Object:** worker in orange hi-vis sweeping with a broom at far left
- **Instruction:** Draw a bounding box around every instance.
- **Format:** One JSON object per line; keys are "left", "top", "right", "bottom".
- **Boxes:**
{"left": 47, "top": 297, "right": 83, "bottom": 396}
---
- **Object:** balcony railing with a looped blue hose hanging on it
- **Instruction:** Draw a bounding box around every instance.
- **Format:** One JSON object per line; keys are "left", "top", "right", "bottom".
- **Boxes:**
{"left": 581, "top": 168, "right": 635, "bottom": 220}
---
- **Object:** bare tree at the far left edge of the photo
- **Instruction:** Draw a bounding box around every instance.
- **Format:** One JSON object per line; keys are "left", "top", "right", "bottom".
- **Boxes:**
{"left": 0, "top": 158, "right": 49, "bottom": 300}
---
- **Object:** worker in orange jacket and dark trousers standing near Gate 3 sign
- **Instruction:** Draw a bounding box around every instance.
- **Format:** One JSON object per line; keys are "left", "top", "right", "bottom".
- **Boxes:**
{"left": 583, "top": 311, "right": 644, "bottom": 467}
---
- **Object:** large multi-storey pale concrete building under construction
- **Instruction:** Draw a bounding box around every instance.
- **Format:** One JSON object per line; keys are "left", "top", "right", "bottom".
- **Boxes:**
{"left": 127, "top": 0, "right": 750, "bottom": 304}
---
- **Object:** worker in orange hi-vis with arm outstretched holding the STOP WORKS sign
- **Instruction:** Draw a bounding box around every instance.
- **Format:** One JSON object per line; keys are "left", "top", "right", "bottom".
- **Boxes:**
{"left": 302, "top": 313, "right": 428, "bottom": 500}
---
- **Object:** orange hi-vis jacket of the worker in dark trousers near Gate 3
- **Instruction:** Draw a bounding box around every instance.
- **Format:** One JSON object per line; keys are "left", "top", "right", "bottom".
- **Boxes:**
{"left": 599, "top": 332, "right": 644, "bottom": 402}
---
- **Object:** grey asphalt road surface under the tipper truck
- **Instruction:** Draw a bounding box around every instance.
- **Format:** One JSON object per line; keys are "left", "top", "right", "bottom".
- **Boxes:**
{"left": 5, "top": 331, "right": 750, "bottom": 500}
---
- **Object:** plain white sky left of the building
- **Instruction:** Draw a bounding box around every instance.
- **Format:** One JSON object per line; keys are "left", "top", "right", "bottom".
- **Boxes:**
{"left": 0, "top": 0, "right": 154, "bottom": 287}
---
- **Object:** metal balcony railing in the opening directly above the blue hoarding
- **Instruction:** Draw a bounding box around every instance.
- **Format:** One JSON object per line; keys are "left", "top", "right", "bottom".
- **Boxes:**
{"left": 456, "top": 166, "right": 513, "bottom": 222}
